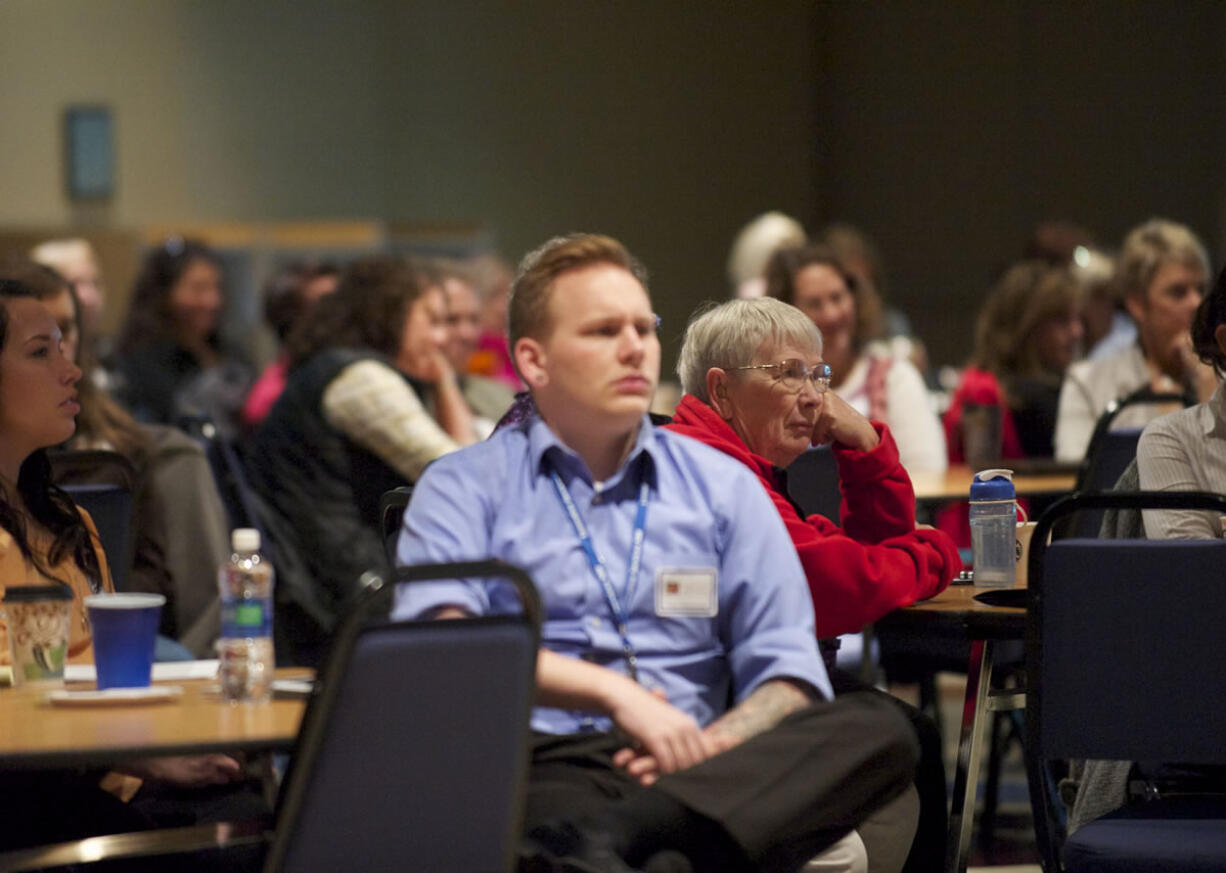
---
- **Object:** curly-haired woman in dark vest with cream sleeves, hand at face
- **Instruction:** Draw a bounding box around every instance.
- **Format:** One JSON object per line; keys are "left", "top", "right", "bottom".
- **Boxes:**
{"left": 250, "top": 256, "right": 474, "bottom": 663}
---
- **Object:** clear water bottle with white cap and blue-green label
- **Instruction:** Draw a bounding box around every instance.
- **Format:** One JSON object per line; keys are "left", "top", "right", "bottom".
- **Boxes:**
{"left": 217, "top": 527, "right": 275, "bottom": 703}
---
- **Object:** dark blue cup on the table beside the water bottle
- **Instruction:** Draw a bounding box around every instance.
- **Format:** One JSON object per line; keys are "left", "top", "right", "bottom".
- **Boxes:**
{"left": 85, "top": 593, "right": 166, "bottom": 692}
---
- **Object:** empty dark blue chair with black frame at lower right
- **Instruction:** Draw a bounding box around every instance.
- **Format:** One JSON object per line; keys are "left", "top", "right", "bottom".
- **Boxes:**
{"left": 1026, "top": 492, "right": 1226, "bottom": 873}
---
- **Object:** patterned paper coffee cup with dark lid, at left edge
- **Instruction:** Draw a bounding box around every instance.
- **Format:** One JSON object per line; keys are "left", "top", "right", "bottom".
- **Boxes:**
{"left": 4, "top": 585, "right": 72, "bottom": 685}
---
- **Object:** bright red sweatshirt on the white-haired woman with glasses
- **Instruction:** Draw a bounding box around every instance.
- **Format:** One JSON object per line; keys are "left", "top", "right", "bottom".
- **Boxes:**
{"left": 666, "top": 395, "right": 962, "bottom": 638}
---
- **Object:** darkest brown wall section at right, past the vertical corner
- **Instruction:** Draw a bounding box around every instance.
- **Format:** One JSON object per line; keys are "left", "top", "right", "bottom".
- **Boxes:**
{"left": 818, "top": 0, "right": 1226, "bottom": 363}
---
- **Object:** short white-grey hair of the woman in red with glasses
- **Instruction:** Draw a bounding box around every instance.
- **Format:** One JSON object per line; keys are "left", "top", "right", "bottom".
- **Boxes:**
{"left": 677, "top": 297, "right": 821, "bottom": 403}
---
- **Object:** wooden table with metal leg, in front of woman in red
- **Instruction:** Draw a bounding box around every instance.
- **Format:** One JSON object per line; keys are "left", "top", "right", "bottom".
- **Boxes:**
{"left": 877, "top": 585, "right": 1026, "bottom": 873}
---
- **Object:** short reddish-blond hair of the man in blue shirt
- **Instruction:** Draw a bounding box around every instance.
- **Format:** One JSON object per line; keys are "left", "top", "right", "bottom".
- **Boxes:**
{"left": 506, "top": 233, "right": 647, "bottom": 354}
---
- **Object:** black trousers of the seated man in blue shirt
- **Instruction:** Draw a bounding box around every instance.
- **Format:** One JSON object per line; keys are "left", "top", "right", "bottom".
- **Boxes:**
{"left": 525, "top": 694, "right": 918, "bottom": 871}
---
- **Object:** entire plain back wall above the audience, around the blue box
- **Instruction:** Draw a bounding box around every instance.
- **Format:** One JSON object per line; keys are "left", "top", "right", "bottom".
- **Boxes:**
{"left": 0, "top": 0, "right": 1226, "bottom": 365}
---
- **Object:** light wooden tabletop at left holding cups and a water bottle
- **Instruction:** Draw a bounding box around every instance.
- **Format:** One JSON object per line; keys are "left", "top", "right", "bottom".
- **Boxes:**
{"left": 0, "top": 669, "right": 310, "bottom": 769}
